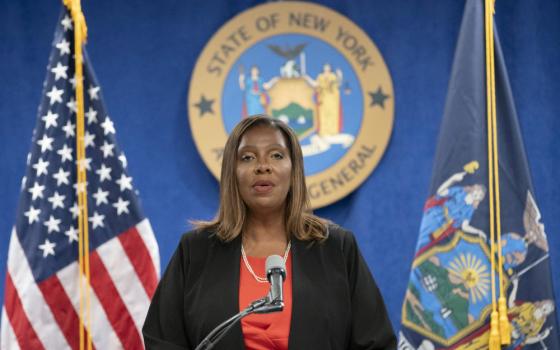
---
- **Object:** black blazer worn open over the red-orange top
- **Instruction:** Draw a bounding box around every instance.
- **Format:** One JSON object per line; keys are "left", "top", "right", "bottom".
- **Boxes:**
{"left": 142, "top": 225, "right": 396, "bottom": 350}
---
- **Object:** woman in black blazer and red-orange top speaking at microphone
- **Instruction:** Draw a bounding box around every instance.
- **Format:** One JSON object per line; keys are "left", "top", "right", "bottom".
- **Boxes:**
{"left": 143, "top": 115, "right": 396, "bottom": 350}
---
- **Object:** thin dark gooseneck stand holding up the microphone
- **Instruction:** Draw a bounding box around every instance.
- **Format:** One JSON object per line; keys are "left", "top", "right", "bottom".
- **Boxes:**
{"left": 195, "top": 296, "right": 284, "bottom": 350}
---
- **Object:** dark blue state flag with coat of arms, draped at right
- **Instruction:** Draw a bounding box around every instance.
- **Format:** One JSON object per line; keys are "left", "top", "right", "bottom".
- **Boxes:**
{"left": 399, "top": 0, "right": 560, "bottom": 350}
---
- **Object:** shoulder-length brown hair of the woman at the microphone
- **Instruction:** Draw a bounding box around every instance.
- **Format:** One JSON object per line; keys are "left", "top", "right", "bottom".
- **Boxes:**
{"left": 197, "top": 114, "right": 327, "bottom": 242}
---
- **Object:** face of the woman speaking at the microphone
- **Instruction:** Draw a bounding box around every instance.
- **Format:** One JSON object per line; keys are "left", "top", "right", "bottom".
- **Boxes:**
{"left": 236, "top": 125, "right": 292, "bottom": 214}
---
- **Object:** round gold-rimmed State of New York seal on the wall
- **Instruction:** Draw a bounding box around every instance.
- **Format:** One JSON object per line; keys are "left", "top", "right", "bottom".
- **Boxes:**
{"left": 187, "top": 1, "right": 394, "bottom": 208}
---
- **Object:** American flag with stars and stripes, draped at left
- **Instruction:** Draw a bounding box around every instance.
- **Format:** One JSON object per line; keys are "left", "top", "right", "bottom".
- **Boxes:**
{"left": 0, "top": 9, "right": 160, "bottom": 349}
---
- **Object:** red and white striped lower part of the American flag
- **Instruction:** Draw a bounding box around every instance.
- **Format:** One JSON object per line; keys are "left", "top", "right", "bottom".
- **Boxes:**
{"left": 0, "top": 219, "right": 160, "bottom": 350}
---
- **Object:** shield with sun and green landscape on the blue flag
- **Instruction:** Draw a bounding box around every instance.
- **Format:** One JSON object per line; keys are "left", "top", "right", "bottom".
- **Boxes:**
{"left": 402, "top": 230, "right": 507, "bottom": 346}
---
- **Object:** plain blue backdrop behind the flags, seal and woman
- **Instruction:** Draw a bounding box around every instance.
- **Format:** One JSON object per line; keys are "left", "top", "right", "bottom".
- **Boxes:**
{"left": 0, "top": 0, "right": 560, "bottom": 327}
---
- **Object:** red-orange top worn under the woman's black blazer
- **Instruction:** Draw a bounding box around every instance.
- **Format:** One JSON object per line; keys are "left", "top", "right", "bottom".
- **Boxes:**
{"left": 239, "top": 253, "right": 292, "bottom": 350}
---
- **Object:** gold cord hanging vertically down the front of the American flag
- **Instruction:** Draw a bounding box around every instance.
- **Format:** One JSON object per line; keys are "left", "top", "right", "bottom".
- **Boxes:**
{"left": 63, "top": 0, "right": 92, "bottom": 350}
